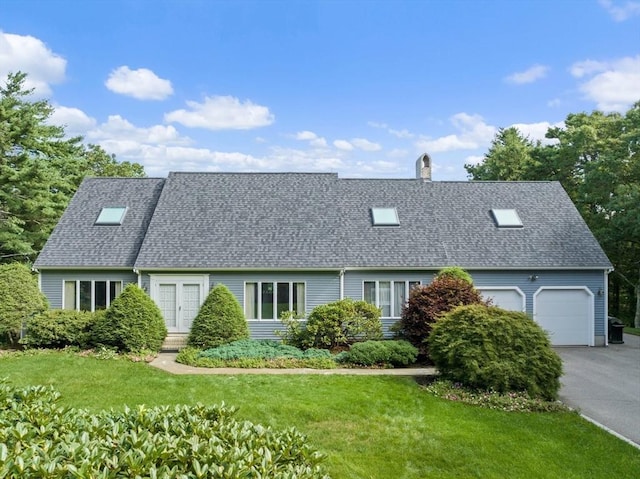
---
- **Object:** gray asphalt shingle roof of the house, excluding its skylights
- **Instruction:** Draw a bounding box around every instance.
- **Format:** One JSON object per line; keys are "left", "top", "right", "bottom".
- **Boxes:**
{"left": 36, "top": 173, "right": 611, "bottom": 270}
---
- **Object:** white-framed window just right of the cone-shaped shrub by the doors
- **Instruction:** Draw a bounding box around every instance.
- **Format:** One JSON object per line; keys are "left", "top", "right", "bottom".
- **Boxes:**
{"left": 244, "top": 281, "right": 306, "bottom": 320}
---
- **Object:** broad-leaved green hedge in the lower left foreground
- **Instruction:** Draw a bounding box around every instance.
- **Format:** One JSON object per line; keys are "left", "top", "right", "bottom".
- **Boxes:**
{"left": 0, "top": 383, "right": 328, "bottom": 479}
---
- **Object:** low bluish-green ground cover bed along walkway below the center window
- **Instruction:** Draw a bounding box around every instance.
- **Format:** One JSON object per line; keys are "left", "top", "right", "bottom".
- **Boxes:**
{"left": 176, "top": 339, "right": 336, "bottom": 369}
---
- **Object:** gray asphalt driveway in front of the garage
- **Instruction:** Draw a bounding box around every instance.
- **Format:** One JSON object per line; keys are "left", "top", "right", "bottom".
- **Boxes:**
{"left": 555, "top": 334, "right": 640, "bottom": 447}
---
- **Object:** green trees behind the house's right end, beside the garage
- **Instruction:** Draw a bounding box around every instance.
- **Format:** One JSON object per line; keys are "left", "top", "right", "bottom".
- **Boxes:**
{"left": 465, "top": 101, "right": 640, "bottom": 328}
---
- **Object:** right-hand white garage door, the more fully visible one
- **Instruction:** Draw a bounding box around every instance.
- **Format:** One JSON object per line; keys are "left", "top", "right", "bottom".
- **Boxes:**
{"left": 533, "top": 288, "right": 593, "bottom": 346}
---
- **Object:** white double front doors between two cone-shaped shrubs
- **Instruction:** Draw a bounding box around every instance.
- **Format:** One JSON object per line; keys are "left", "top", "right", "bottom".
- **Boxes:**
{"left": 151, "top": 275, "right": 209, "bottom": 333}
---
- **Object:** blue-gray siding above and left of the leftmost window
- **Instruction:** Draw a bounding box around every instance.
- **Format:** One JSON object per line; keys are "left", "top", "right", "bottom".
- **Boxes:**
{"left": 40, "top": 270, "right": 138, "bottom": 309}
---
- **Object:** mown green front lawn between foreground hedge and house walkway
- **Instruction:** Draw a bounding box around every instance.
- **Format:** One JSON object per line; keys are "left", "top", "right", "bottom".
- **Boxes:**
{"left": 0, "top": 353, "right": 640, "bottom": 479}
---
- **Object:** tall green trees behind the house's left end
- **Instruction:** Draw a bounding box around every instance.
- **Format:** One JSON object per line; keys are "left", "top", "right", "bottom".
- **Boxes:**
{"left": 0, "top": 72, "right": 145, "bottom": 263}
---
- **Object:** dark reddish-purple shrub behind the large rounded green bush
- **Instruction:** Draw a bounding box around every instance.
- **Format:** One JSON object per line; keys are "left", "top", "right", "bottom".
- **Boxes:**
{"left": 394, "top": 273, "right": 486, "bottom": 355}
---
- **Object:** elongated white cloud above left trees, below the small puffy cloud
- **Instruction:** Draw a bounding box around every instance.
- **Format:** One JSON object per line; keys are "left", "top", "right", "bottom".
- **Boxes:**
{"left": 87, "top": 115, "right": 191, "bottom": 145}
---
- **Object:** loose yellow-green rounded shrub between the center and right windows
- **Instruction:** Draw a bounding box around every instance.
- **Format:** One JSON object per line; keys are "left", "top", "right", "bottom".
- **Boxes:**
{"left": 296, "top": 298, "right": 382, "bottom": 349}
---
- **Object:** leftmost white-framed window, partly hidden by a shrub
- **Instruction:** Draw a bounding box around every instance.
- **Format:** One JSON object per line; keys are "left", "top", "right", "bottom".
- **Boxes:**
{"left": 62, "top": 280, "right": 122, "bottom": 311}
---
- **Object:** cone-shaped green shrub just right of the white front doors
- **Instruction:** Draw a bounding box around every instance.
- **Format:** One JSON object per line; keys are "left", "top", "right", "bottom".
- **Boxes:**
{"left": 187, "top": 283, "right": 249, "bottom": 349}
